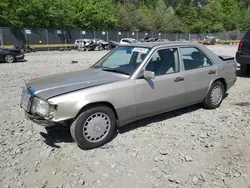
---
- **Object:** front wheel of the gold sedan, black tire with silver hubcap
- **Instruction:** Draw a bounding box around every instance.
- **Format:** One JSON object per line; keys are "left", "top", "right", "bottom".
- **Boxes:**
{"left": 70, "top": 106, "right": 116, "bottom": 150}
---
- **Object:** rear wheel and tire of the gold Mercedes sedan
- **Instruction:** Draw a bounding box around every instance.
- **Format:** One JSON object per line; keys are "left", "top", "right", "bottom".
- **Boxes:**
{"left": 202, "top": 81, "right": 225, "bottom": 109}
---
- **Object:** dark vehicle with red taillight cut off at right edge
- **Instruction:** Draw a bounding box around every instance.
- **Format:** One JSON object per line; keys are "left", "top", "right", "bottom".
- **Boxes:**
{"left": 236, "top": 29, "right": 250, "bottom": 74}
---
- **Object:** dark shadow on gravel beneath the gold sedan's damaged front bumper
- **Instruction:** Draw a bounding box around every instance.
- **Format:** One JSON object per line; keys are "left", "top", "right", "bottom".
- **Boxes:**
{"left": 40, "top": 128, "right": 75, "bottom": 148}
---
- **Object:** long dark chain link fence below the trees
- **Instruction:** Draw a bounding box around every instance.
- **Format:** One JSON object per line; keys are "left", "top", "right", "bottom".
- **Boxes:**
{"left": 0, "top": 28, "right": 245, "bottom": 50}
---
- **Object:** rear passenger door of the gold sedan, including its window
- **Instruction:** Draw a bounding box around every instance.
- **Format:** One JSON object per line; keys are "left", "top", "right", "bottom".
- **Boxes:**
{"left": 180, "top": 47, "right": 217, "bottom": 105}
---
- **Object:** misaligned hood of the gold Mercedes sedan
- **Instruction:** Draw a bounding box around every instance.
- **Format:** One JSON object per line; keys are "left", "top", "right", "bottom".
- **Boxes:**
{"left": 26, "top": 68, "right": 128, "bottom": 100}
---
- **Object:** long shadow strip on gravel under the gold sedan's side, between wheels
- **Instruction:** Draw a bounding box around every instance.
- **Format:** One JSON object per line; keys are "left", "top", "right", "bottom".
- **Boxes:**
{"left": 118, "top": 104, "right": 201, "bottom": 134}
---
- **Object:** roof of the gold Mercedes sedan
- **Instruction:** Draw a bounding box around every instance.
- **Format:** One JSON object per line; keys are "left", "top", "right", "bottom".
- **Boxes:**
{"left": 120, "top": 41, "right": 200, "bottom": 48}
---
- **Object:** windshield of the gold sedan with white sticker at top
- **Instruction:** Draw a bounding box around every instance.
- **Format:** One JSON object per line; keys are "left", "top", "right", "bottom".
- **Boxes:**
{"left": 92, "top": 46, "right": 150, "bottom": 75}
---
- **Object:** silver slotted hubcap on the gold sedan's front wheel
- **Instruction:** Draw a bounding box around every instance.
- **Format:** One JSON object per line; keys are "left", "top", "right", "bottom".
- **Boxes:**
{"left": 83, "top": 112, "right": 111, "bottom": 142}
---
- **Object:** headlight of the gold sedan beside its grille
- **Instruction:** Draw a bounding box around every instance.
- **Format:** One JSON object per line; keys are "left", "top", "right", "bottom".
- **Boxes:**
{"left": 31, "top": 97, "right": 54, "bottom": 117}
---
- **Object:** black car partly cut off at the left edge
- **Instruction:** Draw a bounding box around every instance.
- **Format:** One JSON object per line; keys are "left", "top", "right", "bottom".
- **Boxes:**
{"left": 0, "top": 48, "right": 24, "bottom": 63}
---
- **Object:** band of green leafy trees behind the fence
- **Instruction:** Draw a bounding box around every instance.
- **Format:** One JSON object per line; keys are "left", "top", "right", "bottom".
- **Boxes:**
{"left": 0, "top": 0, "right": 250, "bottom": 33}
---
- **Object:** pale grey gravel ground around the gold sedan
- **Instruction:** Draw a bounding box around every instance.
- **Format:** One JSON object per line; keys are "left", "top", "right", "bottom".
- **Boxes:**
{"left": 0, "top": 46, "right": 250, "bottom": 188}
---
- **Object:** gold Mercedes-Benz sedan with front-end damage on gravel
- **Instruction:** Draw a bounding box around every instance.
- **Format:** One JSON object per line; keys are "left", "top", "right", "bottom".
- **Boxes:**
{"left": 21, "top": 42, "right": 236, "bottom": 149}
